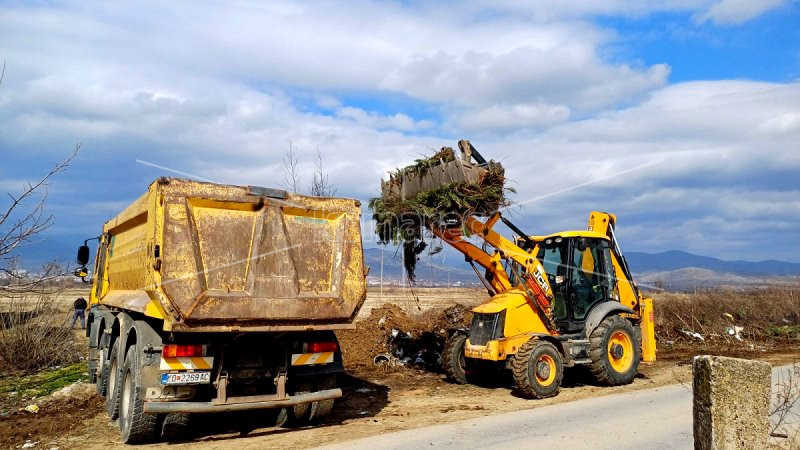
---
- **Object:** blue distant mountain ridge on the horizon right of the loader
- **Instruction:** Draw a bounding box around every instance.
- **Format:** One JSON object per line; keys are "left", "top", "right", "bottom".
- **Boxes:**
{"left": 625, "top": 250, "right": 800, "bottom": 276}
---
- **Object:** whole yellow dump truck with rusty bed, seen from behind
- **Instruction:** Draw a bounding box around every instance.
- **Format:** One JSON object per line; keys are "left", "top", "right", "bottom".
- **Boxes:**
{"left": 73, "top": 178, "right": 366, "bottom": 443}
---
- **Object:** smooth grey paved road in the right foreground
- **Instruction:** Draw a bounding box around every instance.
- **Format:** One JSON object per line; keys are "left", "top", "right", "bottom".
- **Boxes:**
{"left": 325, "top": 367, "right": 800, "bottom": 450}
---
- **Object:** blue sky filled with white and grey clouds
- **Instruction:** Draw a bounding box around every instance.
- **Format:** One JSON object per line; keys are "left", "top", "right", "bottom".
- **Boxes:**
{"left": 0, "top": 0, "right": 800, "bottom": 262}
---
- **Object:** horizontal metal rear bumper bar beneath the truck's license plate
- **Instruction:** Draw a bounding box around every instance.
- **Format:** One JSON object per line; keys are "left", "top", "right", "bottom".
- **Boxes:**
{"left": 144, "top": 388, "right": 342, "bottom": 414}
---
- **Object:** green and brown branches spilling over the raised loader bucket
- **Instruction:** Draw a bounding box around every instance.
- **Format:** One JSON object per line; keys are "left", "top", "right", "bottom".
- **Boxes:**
{"left": 369, "top": 147, "right": 514, "bottom": 281}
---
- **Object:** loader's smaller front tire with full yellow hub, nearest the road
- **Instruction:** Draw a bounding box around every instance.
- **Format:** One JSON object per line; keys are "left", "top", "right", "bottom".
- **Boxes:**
{"left": 511, "top": 339, "right": 564, "bottom": 398}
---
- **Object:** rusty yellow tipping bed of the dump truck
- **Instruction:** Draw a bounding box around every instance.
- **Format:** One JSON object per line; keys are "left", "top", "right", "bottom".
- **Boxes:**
{"left": 93, "top": 178, "right": 366, "bottom": 331}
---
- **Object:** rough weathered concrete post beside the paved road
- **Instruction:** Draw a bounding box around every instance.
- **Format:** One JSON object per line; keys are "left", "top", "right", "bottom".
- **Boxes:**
{"left": 692, "top": 356, "right": 772, "bottom": 450}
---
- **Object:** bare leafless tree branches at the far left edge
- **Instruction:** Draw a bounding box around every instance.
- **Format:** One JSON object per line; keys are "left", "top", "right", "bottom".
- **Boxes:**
{"left": 0, "top": 144, "right": 81, "bottom": 292}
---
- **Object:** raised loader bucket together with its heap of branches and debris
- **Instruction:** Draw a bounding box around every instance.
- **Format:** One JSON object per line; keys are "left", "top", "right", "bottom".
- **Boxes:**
{"left": 369, "top": 140, "right": 514, "bottom": 281}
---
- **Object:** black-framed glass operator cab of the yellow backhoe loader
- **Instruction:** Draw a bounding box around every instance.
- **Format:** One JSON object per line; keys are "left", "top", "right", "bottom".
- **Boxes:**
{"left": 537, "top": 235, "right": 615, "bottom": 333}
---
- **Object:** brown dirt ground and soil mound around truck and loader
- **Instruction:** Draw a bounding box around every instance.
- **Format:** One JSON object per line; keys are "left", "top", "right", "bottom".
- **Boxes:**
{"left": 0, "top": 291, "right": 798, "bottom": 449}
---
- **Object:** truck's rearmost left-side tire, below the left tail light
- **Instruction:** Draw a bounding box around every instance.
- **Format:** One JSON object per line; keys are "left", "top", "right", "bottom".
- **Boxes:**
{"left": 118, "top": 345, "right": 158, "bottom": 444}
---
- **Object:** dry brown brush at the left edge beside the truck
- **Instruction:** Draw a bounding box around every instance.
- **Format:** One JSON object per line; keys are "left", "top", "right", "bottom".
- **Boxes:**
{"left": 0, "top": 292, "right": 81, "bottom": 373}
